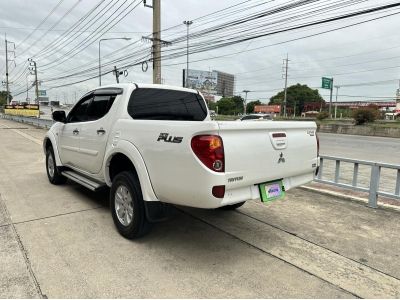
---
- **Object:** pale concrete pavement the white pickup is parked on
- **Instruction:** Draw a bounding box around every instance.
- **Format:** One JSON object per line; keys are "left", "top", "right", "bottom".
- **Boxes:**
{"left": 0, "top": 120, "right": 400, "bottom": 298}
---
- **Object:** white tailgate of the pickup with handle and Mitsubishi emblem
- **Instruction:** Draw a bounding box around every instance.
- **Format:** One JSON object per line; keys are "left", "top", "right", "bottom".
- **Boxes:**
{"left": 218, "top": 121, "right": 317, "bottom": 187}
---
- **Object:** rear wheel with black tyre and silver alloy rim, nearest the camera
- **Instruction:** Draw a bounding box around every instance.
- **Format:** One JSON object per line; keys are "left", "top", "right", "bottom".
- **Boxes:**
{"left": 110, "top": 171, "right": 151, "bottom": 239}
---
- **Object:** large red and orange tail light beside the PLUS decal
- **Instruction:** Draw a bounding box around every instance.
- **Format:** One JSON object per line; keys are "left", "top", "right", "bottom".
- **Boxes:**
{"left": 191, "top": 135, "right": 225, "bottom": 172}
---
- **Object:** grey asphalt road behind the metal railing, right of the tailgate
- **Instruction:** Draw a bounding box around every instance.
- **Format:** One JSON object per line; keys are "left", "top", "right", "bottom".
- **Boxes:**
{"left": 318, "top": 133, "right": 400, "bottom": 165}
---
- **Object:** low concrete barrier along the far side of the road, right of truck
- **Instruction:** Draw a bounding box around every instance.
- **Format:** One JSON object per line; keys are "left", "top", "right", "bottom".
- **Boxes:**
{"left": 318, "top": 124, "right": 400, "bottom": 138}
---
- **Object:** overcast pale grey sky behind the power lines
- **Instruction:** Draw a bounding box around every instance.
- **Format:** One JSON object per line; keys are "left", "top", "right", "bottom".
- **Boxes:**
{"left": 0, "top": 0, "right": 400, "bottom": 103}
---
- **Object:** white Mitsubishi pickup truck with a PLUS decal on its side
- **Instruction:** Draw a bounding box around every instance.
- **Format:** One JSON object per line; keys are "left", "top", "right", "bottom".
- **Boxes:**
{"left": 43, "top": 84, "right": 318, "bottom": 238}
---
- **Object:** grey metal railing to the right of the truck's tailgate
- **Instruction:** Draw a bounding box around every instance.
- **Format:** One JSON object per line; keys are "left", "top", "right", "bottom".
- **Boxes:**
{"left": 314, "top": 155, "right": 400, "bottom": 208}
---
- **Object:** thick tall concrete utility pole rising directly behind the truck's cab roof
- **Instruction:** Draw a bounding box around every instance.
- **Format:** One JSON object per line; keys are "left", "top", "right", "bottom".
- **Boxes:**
{"left": 153, "top": 0, "right": 161, "bottom": 84}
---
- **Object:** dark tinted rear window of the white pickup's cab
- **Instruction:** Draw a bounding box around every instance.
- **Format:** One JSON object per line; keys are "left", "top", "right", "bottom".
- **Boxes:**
{"left": 128, "top": 88, "right": 207, "bottom": 121}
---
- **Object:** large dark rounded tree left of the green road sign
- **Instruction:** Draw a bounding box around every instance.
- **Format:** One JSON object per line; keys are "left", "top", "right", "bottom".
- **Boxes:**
{"left": 269, "top": 83, "right": 325, "bottom": 114}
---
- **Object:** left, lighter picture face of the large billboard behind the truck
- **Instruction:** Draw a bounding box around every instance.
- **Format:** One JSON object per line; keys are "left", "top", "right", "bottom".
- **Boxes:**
{"left": 183, "top": 69, "right": 218, "bottom": 95}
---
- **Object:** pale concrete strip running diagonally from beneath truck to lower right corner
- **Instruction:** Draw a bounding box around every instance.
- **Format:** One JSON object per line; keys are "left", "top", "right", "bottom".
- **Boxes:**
{"left": 184, "top": 208, "right": 400, "bottom": 298}
